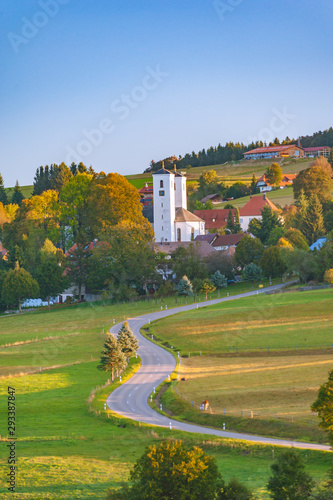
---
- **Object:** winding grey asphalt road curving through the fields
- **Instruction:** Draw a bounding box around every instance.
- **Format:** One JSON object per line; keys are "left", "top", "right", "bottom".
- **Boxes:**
{"left": 106, "top": 285, "right": 330, "bottom": 451}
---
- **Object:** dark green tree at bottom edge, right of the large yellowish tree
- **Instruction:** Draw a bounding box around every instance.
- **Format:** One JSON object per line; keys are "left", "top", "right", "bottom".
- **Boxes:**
{"left": 267, "top": 448, "right": 314, "bottom": 500}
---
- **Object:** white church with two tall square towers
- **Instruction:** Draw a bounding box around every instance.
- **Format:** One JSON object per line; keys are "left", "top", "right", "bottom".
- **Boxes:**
{"left": 153, "top": 163, "right": 205, "bottom": 243}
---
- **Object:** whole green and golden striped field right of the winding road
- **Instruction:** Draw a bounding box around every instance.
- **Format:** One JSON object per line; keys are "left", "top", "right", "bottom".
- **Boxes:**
{"left": 148, "top": 289, "right": 333, "bottom": 442}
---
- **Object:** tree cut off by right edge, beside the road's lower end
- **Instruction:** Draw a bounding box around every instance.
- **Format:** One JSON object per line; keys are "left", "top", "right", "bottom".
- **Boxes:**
{"left": 311, "top": 370, "right": 333, "bottom": 446}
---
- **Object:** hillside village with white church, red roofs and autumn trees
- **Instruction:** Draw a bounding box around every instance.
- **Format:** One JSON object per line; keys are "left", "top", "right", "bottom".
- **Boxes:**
{"left": 0, "top": 138, "right": 333, "bottom": 309}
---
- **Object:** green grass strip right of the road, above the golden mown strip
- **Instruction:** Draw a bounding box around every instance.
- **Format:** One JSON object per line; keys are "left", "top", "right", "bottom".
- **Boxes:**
{"left": 149, "top": 289, "right": 333, "bottom": 355}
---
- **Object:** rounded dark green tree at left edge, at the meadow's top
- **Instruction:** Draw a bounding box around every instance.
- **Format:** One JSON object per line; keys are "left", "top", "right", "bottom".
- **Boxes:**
{"left": 1, "top": 262, "right": 39, "bottom": 311}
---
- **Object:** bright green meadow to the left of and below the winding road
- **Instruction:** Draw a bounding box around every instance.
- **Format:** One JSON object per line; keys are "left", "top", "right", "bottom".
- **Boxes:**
{"left": 0, "top": 292, "right": 331, "bottom": 500}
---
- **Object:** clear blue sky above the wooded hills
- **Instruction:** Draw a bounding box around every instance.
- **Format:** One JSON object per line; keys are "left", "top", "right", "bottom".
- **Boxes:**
{"left": 0, "top": 0, "right": 333, "bottom": 186}
